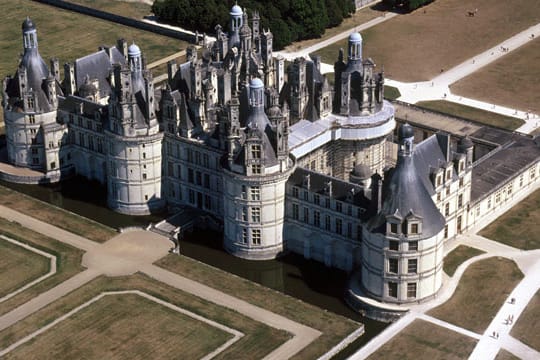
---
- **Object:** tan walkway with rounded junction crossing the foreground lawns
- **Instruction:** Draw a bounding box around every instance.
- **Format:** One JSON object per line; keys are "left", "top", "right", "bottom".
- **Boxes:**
{"left": 0, "top": 205, "right": 321, "bottom": 359}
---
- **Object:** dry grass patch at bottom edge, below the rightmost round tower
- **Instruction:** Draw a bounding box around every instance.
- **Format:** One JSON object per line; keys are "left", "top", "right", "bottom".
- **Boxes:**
{"left": 368, "top": 320, "right": 476, "bottom": 360}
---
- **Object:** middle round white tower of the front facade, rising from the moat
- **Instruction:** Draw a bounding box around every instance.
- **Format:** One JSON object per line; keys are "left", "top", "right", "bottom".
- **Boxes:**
{"left": 223, "top": 78, "right": 294, "bottom": 260}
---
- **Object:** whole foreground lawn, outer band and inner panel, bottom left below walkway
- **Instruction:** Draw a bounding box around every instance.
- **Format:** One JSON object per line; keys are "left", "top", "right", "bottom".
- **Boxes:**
{"left": 0, "top": 274, "right": 290, "bottom": 359}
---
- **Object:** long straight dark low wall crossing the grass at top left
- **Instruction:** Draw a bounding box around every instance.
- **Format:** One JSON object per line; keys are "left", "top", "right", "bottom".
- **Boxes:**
{"left": 34, "top": 0, "right": 196, "bottom": 44}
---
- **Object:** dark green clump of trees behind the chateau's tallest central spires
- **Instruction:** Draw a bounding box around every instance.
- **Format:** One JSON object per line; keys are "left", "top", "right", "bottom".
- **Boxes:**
{"left": 152, "top": 0, "right": 355, "bottom": 49}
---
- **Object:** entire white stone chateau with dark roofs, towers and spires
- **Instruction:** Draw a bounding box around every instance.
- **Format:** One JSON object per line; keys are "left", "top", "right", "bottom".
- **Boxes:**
{"left": 4, "top": 5, "right": 540, "bottom": 317}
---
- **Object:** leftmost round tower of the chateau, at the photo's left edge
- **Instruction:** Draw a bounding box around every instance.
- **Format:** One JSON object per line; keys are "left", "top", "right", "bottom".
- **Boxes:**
{"left": 3, "top": 18, "right": 66, "bottom": 182}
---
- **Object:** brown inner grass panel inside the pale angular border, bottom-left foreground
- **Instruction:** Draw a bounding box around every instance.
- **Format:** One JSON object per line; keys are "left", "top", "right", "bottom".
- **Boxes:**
{"left": 5, "top": 294, "right": 233, "bottom": 359}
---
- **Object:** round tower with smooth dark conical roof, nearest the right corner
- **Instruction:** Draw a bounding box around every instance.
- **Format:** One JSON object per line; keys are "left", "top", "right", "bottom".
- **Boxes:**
{"left": 353, "top": 124, "right": 445, "bottom": 314}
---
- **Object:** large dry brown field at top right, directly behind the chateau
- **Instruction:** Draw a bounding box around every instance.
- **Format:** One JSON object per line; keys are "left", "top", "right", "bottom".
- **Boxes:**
{"left": 318, "top": 0, "right": 540, "bottom": 84}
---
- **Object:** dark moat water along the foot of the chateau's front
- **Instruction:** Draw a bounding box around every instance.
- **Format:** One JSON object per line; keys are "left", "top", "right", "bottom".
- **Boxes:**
{"left": 0, "top": 178, "right": 386, "bottom": 358}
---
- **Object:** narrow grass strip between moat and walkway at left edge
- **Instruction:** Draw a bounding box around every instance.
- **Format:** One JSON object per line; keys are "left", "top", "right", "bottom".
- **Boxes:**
{"left": 0, "top": 186, "right": 117, "bottom": 242}
